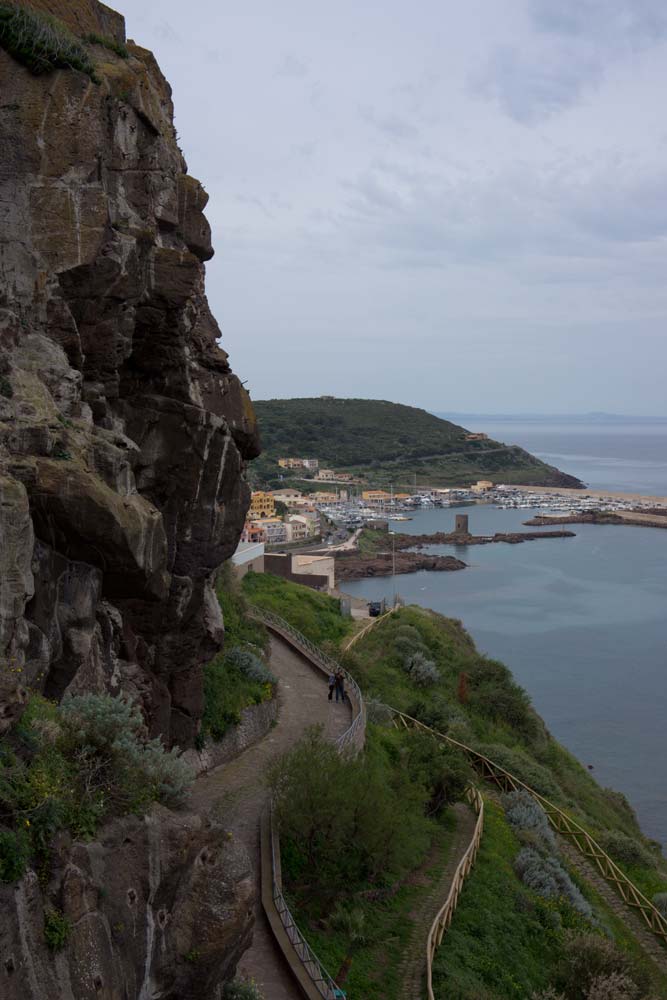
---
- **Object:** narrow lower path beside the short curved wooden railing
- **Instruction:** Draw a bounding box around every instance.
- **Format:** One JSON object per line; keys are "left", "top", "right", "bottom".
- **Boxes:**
{"left": 401, "top": 802, "right": 477, "bottom": 1000}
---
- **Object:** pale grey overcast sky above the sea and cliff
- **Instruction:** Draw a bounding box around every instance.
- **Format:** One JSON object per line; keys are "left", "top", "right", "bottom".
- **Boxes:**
{"left": 117, "top": 0, "right": 667, "bottom": 414}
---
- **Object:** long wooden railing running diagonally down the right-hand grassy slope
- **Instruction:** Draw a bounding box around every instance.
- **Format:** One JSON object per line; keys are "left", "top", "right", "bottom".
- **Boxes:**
{"left": 391, "top": 709, "right": 667, "bottom": 945}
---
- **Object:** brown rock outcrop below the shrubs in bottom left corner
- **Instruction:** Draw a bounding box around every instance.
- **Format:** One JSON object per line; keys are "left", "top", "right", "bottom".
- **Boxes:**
{"left": 0, "top": 806, "right": 255, "bottom": 1000}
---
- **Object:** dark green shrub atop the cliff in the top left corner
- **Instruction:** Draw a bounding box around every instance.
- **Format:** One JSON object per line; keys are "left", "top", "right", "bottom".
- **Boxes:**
{"left": 0, "top": 0, "right": 98, "bottom": 82}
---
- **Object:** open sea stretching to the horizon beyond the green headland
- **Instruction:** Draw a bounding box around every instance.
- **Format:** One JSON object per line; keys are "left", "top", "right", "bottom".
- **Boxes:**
{"left": 471, "top": 417, "right": 667, "bottom": 496}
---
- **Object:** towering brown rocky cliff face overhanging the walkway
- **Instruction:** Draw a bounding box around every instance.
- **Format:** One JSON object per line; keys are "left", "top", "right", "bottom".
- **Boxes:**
{"left": 0, "top": 0, "right": 258, "bottom": 746}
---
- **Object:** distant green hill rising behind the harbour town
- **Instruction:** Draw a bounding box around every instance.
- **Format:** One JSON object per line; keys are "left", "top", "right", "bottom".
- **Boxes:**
{"left": 252, "top": 396, "right": 581, "bottom": 488}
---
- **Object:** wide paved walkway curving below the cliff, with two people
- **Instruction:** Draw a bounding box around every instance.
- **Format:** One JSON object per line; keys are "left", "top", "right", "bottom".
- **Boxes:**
{"left": 191, "top": 637, "right": 352, "bottom": 1000}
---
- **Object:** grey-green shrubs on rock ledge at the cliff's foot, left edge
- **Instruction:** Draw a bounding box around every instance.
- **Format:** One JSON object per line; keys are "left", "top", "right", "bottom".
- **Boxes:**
{"left": 0, "top": 694, "right": 193, "bottom": 882}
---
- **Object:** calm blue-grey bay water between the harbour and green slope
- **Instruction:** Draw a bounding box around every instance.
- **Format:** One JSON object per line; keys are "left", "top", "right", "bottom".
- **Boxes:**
{"left": 345, "top": 504, "right": 667, "bottom": 844}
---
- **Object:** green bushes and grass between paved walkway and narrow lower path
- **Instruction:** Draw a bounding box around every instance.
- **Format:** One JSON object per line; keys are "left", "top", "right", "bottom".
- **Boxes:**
{"left": 271, "top": 726, "right": 470, "bottom": 1000}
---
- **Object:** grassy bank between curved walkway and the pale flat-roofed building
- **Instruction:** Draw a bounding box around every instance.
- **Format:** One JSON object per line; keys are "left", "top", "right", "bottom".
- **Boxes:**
{"left": 242, "top": 573, "right": 354, "bottom": 649}
